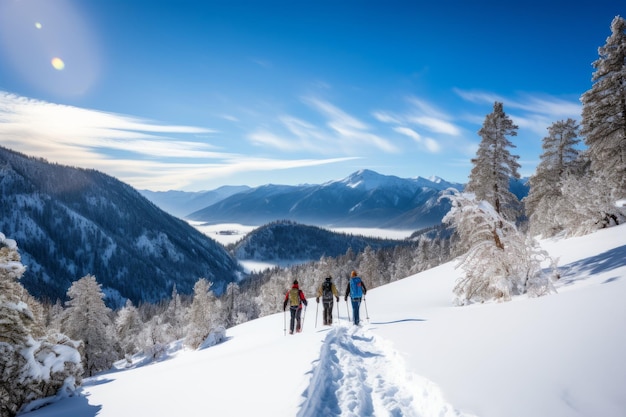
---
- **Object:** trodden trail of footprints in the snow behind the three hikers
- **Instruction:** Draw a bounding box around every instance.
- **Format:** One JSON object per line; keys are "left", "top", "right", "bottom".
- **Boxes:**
{"left": 298, "top": 327, "right": 470, "bottom": 417}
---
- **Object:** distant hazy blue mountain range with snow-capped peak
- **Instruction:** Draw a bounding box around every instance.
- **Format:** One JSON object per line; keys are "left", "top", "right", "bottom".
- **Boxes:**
{"left": 187, "top": 170, "right": 463, "bottom": 230}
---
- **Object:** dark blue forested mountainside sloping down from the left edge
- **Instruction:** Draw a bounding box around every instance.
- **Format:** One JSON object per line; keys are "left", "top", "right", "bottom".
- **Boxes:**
{"left": 0, "top": 147, "right": 241, "bottom": 304}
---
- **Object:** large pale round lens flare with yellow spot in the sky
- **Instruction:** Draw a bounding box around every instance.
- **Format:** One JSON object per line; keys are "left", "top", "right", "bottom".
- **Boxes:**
{"left": 0, "top": 0, "right": 101, "bottom": 97}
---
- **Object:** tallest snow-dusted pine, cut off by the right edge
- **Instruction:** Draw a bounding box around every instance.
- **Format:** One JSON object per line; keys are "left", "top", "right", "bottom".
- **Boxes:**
{"left": 581, "top": 16, "right": 626, "bottom": 211}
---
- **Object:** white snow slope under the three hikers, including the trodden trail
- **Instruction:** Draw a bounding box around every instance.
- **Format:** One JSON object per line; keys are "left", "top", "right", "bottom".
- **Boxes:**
{"left": 25, "top": 226, "right": 626, "bottom": 417}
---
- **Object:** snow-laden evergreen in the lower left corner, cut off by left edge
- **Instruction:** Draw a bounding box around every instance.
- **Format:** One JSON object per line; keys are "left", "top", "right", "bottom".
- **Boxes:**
{"left": 0, "top": 233, "right": 82, "bottom": 417}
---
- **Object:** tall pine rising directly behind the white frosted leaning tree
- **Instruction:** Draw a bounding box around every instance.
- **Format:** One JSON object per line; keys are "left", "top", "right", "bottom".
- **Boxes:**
{"left": 465, "top": 101, "right": 520, "bottom": 221}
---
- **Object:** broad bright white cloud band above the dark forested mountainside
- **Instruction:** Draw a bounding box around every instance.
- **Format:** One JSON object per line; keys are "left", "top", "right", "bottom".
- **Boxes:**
{"left": 0, "top": 91, "right": 355, "bottom": 190}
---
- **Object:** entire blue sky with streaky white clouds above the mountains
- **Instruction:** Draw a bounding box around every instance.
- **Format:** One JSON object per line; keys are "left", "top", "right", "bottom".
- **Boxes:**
{"left": 0, "top": 0, "right": 626, "bottom": 191}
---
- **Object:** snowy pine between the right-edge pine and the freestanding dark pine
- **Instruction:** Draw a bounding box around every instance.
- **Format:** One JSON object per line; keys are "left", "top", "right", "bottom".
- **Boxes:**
{"left": 524, "top": 119, "right": 580, "bottom": 237}
